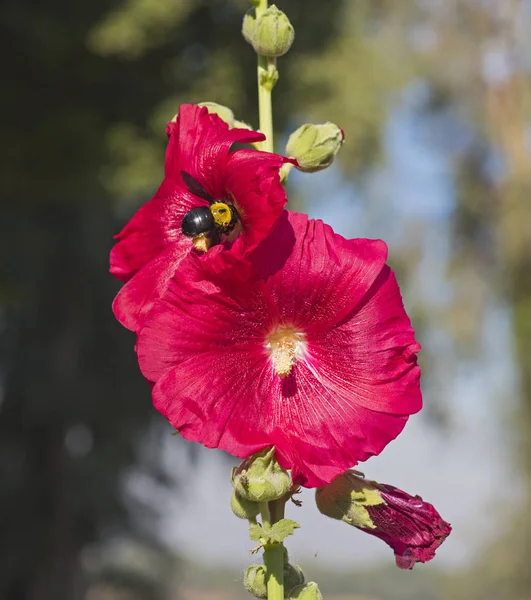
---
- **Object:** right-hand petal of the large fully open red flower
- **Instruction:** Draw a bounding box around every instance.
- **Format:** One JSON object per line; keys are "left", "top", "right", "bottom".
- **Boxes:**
{"left": 308, "top": 266, "right": 422, "bottom": 415}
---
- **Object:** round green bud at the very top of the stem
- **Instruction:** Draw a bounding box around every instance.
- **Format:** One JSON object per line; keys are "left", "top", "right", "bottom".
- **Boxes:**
{"left": 249, "top": 4, "right": 295, "bottom": 58}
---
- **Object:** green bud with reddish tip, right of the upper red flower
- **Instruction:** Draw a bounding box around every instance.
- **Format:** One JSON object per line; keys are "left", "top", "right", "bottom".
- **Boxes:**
{"left": 286, "top": 122, "right": 345, "bottom": 173}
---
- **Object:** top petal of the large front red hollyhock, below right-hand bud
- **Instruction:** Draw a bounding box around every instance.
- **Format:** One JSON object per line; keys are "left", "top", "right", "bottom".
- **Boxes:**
{"left": 253, "top": 211, "right": 387, "bottom": 332}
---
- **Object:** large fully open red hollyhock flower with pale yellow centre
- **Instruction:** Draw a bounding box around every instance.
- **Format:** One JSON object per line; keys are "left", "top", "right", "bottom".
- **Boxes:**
{"left": 137, "top": 211, "right": 421, "bottom": 487}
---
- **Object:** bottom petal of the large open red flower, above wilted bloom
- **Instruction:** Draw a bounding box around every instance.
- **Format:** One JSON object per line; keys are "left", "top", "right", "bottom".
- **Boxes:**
{"left": 270, "top": 361, "right": 407, "bottom": 487}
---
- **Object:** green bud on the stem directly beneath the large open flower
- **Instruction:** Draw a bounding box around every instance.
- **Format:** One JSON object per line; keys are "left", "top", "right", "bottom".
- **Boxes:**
{"left": 231, "top": 448, "right": 292, "bottom": 502}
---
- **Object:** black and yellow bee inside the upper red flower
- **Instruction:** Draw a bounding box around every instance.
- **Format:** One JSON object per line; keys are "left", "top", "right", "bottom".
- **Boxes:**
{"left": 181, "top": 171, "right": 239, "bottom": 250}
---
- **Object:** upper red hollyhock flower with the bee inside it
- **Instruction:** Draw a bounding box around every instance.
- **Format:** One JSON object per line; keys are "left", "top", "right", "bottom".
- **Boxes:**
{"left": 110, "top": 104, "right": 288, "bottom": 331}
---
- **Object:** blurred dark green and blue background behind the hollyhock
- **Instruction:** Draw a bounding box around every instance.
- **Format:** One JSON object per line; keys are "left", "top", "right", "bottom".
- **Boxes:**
{"left": 0, "top": 0, "right": 531, "bottom": 600}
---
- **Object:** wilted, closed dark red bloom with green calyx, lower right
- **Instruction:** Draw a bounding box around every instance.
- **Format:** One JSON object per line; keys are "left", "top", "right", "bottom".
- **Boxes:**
{"left": 315, "top": 471, "right": 452, "bottom": 569}
